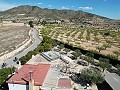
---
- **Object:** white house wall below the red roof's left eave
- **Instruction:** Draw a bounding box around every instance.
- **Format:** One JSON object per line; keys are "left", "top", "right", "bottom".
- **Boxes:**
{"left": 8, "top": 83, "right": 29, "bottom": 90}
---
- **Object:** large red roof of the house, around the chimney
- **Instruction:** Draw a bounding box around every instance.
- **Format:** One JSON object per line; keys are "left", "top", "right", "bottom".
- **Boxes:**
{"left": 7, "top": 64, "right": 50, "bottom": 86}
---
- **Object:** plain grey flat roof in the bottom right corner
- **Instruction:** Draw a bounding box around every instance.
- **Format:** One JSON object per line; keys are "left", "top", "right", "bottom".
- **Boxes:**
{"left": 105, "top": 73, "right": 120, "bottom": 90}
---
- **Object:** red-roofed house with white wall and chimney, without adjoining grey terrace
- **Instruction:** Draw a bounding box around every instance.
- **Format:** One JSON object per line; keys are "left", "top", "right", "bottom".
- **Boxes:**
{"left": 7, "top": 64, "right": 50, "bottom": 90}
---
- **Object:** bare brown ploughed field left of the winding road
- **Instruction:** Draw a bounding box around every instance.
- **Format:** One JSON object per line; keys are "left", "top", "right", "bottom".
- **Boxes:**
{"left": 0, "top": 26, "right": 30, "bottom": 56}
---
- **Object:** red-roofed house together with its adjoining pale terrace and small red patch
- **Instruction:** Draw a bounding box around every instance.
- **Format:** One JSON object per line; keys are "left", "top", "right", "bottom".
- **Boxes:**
{"left": 7, "top": 64, "right": 72, "bottom": 90}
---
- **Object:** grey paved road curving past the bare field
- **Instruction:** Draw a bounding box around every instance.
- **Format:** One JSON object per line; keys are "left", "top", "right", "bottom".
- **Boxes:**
{"left": 0, "top": 29, "right": 42, "bottom": 68}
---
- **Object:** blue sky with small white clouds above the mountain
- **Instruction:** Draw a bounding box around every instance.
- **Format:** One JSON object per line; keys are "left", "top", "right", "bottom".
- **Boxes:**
{"left": 0, "top": 0, "right": 120, "bottom": 20}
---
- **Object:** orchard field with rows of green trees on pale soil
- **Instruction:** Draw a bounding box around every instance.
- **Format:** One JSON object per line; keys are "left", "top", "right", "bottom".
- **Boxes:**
{"left": 40, "top": 25, "right": 120, "bottom": 58}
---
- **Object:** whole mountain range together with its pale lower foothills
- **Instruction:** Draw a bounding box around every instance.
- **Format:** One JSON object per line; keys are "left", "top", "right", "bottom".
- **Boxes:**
{"left": 0, "top": 5, "right": 120, "bottom": 27}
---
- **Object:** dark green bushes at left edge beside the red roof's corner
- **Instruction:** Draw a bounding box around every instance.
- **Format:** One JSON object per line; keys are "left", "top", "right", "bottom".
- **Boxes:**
{"left": 0, "top": 68, "right": 14, "bottom": 85}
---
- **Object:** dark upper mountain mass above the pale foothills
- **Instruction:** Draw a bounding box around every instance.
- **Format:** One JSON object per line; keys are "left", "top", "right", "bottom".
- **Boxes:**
{"left": 0, "top": 5, "right": 107, "bottom": 19}
